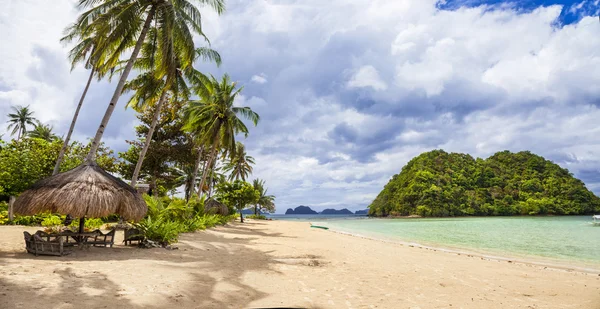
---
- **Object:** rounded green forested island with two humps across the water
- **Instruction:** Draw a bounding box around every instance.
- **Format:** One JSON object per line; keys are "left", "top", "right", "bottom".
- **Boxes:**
{"left": 369, "top": 150, "right": 600, "bottom": 217}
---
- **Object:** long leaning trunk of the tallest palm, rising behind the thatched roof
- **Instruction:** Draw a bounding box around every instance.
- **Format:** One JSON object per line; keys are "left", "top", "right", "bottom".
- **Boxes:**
{"left": 85, "top": 6, "right": 156, "bottom": 162}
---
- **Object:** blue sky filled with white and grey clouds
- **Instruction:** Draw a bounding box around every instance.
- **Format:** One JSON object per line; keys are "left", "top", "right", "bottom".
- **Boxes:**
{"left": 0, "top": 0, "right": 600, "bottom": 212}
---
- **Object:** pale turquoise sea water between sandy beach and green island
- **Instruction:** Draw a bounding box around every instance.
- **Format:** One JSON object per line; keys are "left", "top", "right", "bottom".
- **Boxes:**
{"left": 312, "top": 216, "right": 600, "bottom": 266}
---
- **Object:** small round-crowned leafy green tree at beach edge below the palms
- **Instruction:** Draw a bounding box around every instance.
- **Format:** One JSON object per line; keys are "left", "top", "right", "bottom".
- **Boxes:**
{"left": 217, "top": 180, "right": 260, "bottom": 223}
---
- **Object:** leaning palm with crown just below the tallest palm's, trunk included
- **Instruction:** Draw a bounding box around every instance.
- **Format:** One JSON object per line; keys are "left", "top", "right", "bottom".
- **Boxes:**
{"left": 125, "top": 29, "right": 221, "bottom": 187}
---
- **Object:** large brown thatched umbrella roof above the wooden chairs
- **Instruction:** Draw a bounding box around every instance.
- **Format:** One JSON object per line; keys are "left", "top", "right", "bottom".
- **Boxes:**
{"left": 14, "top": 163, "right": 148, "bottom": 220}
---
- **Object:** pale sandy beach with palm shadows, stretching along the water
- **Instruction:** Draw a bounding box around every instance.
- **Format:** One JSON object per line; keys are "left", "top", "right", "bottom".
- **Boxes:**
{"left": 0, "top": 220, "right": 600, "bottom": 308}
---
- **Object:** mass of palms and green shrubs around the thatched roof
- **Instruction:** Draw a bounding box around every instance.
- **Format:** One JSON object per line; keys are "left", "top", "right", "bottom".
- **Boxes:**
{"left": 0, "top": 0, "right": 275, "bottom": 244}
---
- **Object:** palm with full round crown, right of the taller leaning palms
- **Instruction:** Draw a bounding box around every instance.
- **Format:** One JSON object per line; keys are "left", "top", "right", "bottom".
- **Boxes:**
{"left": 184, "top": 74, "right": 260, "bottom": 195}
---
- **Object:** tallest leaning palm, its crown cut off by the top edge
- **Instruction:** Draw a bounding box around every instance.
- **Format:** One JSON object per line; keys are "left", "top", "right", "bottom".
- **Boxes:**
{"left": 77, "top": 0, "right": 224, "bottom": 162}
